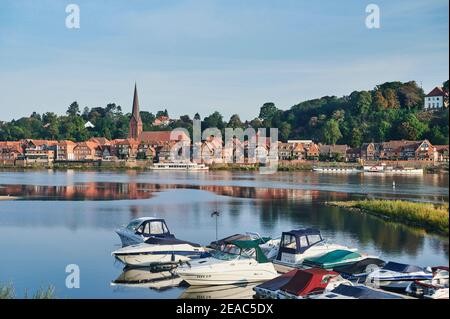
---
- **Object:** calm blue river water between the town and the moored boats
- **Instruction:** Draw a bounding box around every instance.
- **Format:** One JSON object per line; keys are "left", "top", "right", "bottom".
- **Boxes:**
{"left": 0, "top": 170, "right": 449, "bottom": 299}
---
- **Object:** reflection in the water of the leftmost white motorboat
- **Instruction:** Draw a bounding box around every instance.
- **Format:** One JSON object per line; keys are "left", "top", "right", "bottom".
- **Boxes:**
{"left": 111, "top": 268, "right": 182, "bottom": 290}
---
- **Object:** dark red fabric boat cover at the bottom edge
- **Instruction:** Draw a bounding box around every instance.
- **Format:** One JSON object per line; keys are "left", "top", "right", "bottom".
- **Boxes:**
{"left": 280, "top": 268, "right": 339, "bottom": 296}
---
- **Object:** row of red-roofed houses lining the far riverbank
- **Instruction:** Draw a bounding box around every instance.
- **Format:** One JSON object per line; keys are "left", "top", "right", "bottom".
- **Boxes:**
{"left": 0, "top": 137, "right": 449, "bottom": 165}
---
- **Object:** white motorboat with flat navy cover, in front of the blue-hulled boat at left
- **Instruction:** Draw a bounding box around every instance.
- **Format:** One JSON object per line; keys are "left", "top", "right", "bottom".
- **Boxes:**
{"left": 112, "top": 237, "right": 205, "bottom": 267}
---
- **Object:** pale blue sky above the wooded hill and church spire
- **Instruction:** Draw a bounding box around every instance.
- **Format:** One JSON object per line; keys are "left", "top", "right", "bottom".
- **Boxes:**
{"left": 0, "top": 0, "right": 449, "bottom": 120}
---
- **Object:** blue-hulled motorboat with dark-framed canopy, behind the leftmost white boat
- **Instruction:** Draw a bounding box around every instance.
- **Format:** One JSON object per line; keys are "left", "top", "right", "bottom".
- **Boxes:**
{"left": 116, "top": 217, "right": 174, "bottom": 246}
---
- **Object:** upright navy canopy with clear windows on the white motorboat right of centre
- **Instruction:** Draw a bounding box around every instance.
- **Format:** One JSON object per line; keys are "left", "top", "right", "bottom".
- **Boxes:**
{"left": 277, "top": 228, "right": 323, "bottom": 260}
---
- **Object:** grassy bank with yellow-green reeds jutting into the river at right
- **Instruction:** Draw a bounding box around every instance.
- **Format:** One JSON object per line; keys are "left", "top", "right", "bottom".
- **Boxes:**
{"left": 327, "top": 199, "right": 449, "bottom": 235}
